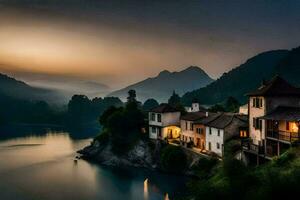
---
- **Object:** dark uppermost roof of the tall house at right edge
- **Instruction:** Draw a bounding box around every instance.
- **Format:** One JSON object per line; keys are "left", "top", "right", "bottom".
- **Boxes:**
{"left": 247, "top": 76, "right": 300, "bottom": 96}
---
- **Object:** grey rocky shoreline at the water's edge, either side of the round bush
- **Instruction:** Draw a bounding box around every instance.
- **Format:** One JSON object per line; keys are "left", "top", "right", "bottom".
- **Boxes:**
{"left": 78, "top": 140, "right": 202, "bottom": 176}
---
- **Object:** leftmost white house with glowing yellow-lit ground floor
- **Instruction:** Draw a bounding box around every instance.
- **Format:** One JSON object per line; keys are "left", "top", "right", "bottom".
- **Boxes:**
{"left": 149, "top": 104, "right": 180, "bottom": 140}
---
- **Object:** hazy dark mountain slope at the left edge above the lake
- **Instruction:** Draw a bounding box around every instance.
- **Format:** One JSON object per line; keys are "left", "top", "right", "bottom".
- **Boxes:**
{"left": 0, "top": 73, "right": 62, "bottom": 103}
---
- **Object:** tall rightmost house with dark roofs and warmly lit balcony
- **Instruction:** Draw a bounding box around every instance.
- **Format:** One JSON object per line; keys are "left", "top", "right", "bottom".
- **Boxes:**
{"left": 243, "top": 76, "right": 300, "bottom": 162}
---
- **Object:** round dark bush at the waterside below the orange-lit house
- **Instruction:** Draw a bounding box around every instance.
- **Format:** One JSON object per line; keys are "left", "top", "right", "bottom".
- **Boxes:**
{"left": 160, "top": 145, "right": 187, "bottom": 173}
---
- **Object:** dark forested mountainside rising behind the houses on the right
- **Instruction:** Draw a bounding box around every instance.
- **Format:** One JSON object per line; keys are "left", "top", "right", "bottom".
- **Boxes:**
{"left": 182, "top": 50, "right": 290, "bottom": 105}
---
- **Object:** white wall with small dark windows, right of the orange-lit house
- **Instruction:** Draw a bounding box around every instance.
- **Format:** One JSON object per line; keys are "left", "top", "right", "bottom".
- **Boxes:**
{"left": 205, "top": 127, "right": 224, "bottom": 157}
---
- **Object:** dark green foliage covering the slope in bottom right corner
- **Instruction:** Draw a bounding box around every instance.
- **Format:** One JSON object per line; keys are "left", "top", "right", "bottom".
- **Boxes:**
{"left": 185, "top": 147, "right": 300, "bottom": 199}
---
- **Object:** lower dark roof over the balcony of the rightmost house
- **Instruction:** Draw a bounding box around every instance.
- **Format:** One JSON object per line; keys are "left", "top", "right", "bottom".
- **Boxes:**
{"left": 261, "top": 106, "right": 300, "bottom": 121}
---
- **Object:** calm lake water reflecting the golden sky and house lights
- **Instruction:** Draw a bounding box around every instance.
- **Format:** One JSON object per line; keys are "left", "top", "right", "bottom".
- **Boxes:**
{"left": 0, "top": 128, "right": 185, "bottom": 200}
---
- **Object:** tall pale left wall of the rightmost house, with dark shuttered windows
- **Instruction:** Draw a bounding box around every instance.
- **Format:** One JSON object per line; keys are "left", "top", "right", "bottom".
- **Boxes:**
{"left": 248, "top": 97, "right": 266, "bottom": 145}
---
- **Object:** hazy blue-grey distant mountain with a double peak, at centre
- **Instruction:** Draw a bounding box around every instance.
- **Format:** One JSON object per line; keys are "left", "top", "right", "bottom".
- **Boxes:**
{"left": 109, "top": 66, "right": 213, "bottom": 102}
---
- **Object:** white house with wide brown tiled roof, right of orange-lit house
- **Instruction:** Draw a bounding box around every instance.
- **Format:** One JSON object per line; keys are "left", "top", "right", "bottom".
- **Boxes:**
{"left": 196, "top": 113, "right": 248, "bottom": 157}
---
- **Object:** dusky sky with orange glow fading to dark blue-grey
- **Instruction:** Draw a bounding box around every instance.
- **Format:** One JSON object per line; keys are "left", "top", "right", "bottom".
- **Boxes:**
{"left": 0, "top": 0, "right": 300, "bottom": 88}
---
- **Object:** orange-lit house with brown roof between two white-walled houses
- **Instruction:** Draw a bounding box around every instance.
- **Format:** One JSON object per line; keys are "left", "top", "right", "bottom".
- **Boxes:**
{"left": 180, "top": 111, "right": 209, "bottom": 150}
